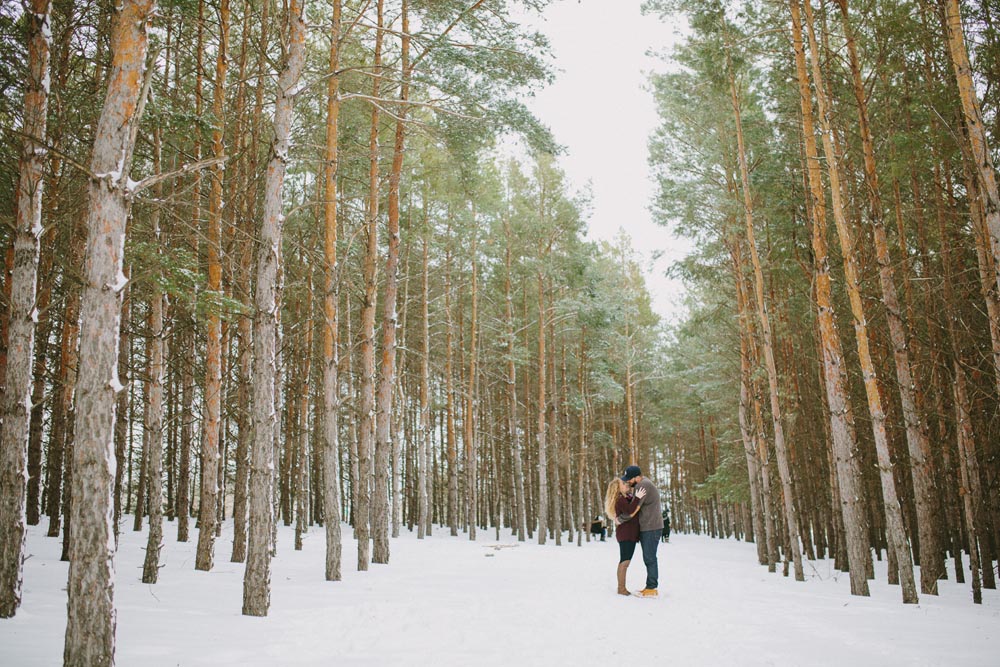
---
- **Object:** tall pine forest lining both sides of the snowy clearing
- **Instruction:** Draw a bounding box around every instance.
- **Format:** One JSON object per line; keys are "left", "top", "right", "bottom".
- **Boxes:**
{"left": 0, "top": 0, "right": 1000, "bottom": 666}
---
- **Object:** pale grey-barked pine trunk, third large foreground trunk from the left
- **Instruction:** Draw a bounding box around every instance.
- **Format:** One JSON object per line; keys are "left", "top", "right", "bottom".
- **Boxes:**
{"left": 243, "top": 0, "right": 306, "bottom": 616}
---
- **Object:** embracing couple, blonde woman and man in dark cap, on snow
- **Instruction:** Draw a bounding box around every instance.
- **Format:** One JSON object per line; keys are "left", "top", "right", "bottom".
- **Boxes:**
{"left": 604, "top": 466, "right": 663, "bottom": 598}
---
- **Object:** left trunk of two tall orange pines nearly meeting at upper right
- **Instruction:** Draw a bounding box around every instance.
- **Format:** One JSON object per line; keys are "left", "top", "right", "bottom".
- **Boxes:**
{"left": 789, "top": 0, "right": 871, "bottom": 596}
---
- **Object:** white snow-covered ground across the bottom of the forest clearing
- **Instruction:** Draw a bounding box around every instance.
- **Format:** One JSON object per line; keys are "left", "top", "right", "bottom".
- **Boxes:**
{"left": 0, "top": 520, "right": 1000, "bottom": 667}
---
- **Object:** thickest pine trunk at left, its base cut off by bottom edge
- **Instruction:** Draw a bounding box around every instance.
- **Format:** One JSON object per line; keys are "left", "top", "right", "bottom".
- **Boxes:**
{"left": 63, "top": 0, "right": 156, "bottom": 667}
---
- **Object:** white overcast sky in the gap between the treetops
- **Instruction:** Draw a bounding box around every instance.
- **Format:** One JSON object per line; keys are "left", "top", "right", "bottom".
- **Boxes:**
{"left": 512, "top": 0, "right": 687, "bottom": 321}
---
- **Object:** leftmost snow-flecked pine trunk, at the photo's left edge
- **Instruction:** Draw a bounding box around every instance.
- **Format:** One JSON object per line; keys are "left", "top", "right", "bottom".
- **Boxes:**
{"left": 0, "top": 0, "right": 52, "bottom": 618}
